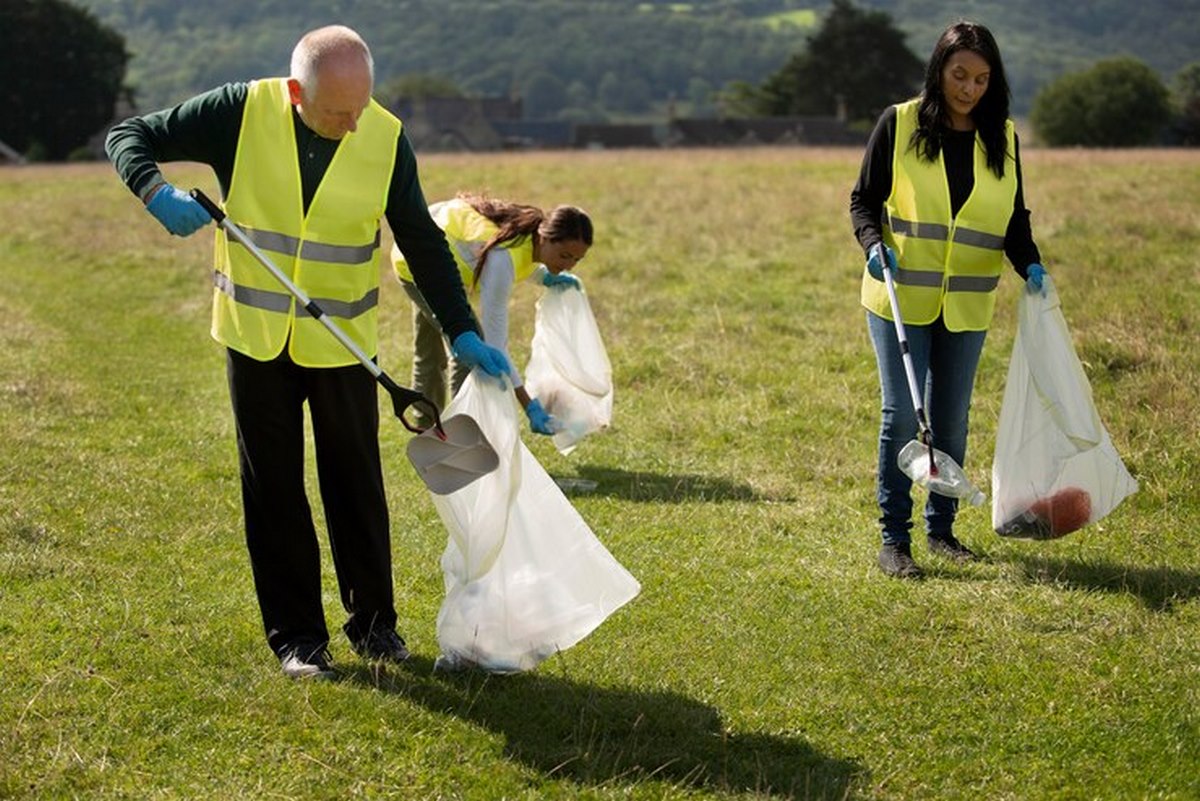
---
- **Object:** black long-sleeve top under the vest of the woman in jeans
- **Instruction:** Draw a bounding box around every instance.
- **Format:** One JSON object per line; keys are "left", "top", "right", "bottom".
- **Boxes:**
{"left": 850, "top": 106, "right": 1042, "bottom": 279}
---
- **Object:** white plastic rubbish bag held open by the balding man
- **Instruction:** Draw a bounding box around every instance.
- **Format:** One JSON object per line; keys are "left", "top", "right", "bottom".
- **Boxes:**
{"left": 432, "top": 369, "right": 641, "bottom": 673}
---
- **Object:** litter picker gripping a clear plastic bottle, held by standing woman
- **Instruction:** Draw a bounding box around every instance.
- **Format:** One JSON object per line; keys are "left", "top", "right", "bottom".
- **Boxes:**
{"left": 877, "top": 242, "right": 986, "bottom": 506}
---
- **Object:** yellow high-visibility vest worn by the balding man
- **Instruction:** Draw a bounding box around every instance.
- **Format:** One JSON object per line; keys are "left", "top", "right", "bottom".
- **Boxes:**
{"left": 212, "top": 78, "right": 401, "bottom": 367}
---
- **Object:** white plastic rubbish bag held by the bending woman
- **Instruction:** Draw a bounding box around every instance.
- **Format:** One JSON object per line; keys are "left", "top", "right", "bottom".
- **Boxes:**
{"left": 526, "top": 289, "right": 613, "bottom": 456}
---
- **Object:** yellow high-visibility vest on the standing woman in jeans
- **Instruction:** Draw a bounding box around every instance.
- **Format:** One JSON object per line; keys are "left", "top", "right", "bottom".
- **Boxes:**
{"left": 862, "top": 100, "right": 1016, "bottom": 331}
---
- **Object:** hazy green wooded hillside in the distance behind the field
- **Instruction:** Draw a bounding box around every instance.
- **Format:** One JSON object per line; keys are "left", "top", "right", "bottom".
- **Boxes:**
{"left": 79, "top": 0, "right": 1200, "bottom": 120}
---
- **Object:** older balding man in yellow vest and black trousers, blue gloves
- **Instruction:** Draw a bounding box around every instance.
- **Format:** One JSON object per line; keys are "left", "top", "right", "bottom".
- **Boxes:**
{"left": 106, "top": 25, "right": 509, "bottom": 679}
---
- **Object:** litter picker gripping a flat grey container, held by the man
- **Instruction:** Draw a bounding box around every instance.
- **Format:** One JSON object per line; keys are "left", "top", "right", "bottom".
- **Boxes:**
{"left": 191, "top": 189, "right": 499, "bottom": 495}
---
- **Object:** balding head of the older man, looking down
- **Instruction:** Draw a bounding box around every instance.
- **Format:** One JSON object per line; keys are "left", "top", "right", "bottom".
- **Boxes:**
{"left": 288, "top": 25, "right": 374, "bottom": 139}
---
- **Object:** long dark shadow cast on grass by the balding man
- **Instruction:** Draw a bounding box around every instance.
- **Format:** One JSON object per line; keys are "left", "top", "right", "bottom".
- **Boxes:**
{"left": 347, "top": 657, "right": 864, "bottom": 799}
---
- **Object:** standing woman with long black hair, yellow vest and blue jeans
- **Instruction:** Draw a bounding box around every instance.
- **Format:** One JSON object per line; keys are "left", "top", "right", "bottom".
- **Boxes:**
{"left": 850, "top": 22, "right": 1045, "bottom": 578}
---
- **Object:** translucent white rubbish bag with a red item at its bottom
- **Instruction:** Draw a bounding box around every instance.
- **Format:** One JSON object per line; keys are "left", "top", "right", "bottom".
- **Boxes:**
{"left": 991, "top": 276, "right": 1138, "bottom": 540}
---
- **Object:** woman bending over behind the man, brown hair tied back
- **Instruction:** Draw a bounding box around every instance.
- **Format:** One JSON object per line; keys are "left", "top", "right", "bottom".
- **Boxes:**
{"left": 392, "top": 193, "right": 592, "bottom": 434}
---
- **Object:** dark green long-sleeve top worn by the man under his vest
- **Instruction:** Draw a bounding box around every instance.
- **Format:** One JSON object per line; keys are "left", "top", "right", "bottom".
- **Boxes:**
{"left": 104, "top": 83, "right": 479, "bottom": 342}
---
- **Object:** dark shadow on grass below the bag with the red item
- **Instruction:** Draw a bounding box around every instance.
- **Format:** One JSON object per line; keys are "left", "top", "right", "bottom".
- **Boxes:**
{"left": 1016, "top": 555, "right": 1200, "bottom": 612}
